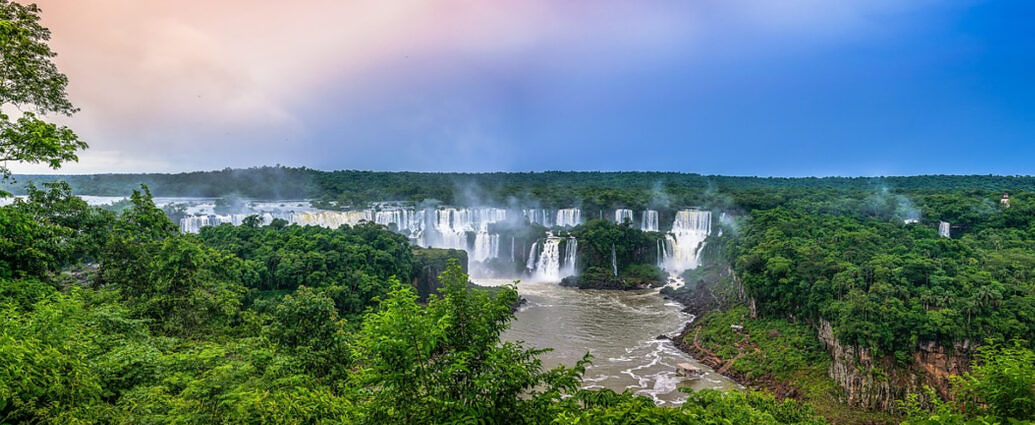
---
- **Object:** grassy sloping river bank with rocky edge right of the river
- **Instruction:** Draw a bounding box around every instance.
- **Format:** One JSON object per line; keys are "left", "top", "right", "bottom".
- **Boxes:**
{"left": 666, "top": 268, "right": 901, "bottom": 424}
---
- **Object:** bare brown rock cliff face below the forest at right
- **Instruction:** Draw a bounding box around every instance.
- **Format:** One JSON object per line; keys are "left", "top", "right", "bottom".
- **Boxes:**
{"left": 819, "top": 321, "right": 972, "bottom": 411}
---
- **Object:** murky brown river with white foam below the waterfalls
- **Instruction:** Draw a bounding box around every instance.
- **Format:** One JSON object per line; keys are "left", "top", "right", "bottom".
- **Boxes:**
{"left": 472, "top": 278, "right": 739, "bottom": 405}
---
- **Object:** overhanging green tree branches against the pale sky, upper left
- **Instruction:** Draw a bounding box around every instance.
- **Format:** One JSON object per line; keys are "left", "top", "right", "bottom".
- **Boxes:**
{"left": 0, "top": 0, "right": 87, "bottom": 189}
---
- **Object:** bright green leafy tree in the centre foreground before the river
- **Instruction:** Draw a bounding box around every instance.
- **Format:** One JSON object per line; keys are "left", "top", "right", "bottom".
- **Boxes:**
{"left": 355, "top": 263, "right": 584, "bottom": 424}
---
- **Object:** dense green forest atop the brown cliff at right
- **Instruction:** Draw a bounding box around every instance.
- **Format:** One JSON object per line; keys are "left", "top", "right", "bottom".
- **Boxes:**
{"left": 731, "top": 194, "right": 1035, "bottom": 361}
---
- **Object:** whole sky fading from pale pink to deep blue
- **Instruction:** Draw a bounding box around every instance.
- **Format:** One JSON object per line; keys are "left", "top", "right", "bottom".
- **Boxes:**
{"left": 9, "top": 0, "right": 1035, "bottom": 176}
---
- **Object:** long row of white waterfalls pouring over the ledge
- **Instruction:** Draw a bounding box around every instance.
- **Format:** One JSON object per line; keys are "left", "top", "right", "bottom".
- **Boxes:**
{"left": 179, "top": 200, "right": 712, "bottom": 286}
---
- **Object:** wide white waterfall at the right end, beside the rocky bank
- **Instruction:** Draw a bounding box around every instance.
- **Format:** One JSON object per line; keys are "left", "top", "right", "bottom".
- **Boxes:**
{"left": 663, "top": 210, "right": 711, "bottom": 275}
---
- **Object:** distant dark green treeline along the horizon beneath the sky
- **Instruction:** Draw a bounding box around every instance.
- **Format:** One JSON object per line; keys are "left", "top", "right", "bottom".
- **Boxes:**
{"left": 3, "top": 166, "right": 1035, "bottom": 207}
